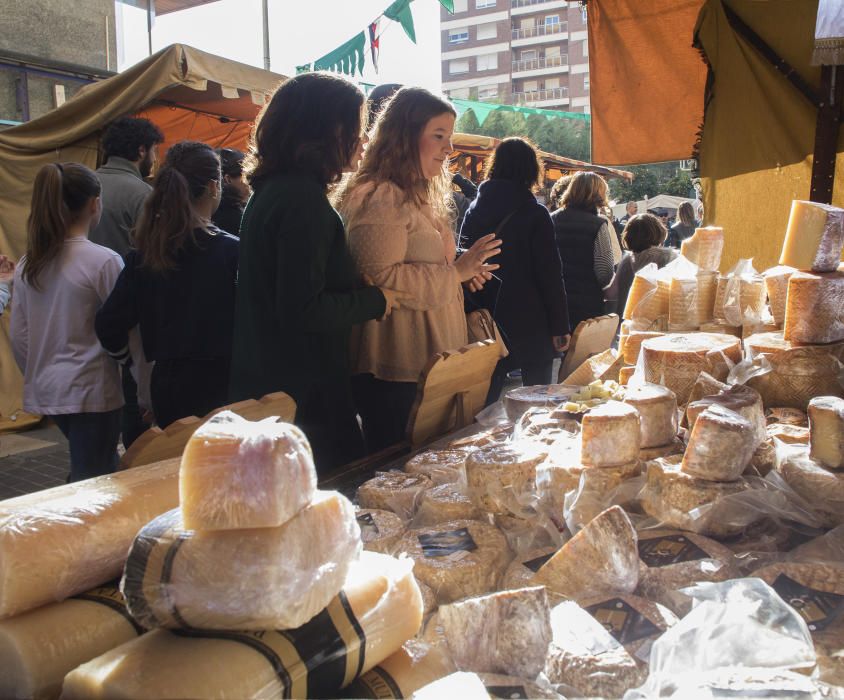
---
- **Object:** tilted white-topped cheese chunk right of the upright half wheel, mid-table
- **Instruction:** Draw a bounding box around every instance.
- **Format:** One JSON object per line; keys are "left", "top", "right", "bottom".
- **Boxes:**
{"left": 681, "top": 403, "right": 759, "bottom": 481}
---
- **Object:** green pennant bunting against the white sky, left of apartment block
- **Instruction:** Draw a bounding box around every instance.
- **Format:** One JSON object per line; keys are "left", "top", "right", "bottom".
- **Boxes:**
{"left": 296, "top": 0, "right": 454, "bottom": 76}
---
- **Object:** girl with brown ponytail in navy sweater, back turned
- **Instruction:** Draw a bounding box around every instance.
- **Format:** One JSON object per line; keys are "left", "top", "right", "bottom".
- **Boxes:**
{"left": 96, "top": 141, "right": 238, "bottom": 428}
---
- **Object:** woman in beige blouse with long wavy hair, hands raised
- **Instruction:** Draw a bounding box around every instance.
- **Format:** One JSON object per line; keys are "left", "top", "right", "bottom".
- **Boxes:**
{"left": 338, "top": 88, "right": 500, "bottom": 452}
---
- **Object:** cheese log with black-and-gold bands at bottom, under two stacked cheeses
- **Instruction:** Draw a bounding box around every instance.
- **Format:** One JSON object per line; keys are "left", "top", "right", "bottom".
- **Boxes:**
{"left": 62, "top": 552, "right": 422, "bottom": 700}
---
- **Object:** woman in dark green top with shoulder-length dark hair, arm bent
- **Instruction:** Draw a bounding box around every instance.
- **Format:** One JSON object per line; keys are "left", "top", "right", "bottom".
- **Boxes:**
{"left": 231, "top": 73, "right": 403, "bottom": 472}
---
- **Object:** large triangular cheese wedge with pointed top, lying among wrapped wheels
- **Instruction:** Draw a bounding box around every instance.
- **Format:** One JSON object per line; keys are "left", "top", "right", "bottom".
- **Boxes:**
{"left": 534, "top": 506, "right": 639, "bottom": 599}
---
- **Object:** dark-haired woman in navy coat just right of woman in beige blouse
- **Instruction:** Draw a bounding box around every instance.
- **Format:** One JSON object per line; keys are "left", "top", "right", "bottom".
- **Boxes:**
{"left": 460, "top": 138, "right": 569, "bottom": 403}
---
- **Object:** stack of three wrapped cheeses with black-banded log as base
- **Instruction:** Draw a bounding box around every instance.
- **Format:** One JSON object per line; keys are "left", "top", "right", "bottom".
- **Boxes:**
{"left": 62, "top": 412, "right": 422, "bottom": 699}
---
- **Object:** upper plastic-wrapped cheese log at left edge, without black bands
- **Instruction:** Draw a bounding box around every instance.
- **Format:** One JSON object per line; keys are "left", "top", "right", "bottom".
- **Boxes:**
{"left": 0, "top": 459, "right": 179, "bottom": 618}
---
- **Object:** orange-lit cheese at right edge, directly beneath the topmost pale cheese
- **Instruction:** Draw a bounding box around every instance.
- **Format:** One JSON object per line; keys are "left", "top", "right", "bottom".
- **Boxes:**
{"left": 782, "top": 270, "right": 844, "bottom": 344}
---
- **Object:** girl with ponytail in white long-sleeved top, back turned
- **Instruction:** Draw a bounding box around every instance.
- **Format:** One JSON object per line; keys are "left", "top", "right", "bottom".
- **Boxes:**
{"left": 11, "top": 163, "right": 123, "bottom": 481}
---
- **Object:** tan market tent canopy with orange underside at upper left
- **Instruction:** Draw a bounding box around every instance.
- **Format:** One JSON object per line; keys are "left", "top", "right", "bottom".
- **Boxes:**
{"left": 0, "top": 45, "right": 285, "bottom": 415}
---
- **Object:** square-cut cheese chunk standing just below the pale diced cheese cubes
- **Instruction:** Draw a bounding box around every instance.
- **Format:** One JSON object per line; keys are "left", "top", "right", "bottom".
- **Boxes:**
{"left": 580, "top": 401, "right": 641, "bottom": 467}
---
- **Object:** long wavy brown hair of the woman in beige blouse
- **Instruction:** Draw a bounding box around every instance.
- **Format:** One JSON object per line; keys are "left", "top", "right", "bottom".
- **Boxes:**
{"left": 334, "top": 87, "right": 457, "bottom": 221}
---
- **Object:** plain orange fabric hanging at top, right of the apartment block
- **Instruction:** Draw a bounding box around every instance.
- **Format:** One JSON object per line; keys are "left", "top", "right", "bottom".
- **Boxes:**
{"left": 587, "top": 0, "right": 706, "bottom": 165}
